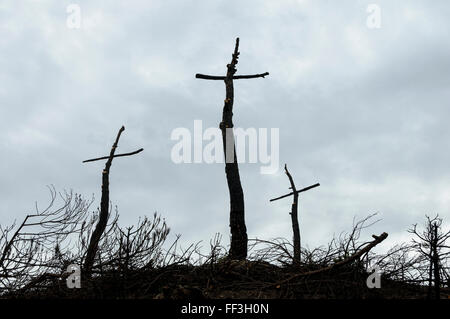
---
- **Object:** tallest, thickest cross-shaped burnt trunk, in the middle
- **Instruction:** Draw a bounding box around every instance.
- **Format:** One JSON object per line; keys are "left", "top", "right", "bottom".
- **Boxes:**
{"left": 195, "top": 38, "right": 269, "bottom": 260}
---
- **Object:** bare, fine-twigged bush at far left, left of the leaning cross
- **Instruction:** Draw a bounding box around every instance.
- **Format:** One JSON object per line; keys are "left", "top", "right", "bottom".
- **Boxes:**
{"left": 0, "top": 187, "right": 93, "bottom": 293}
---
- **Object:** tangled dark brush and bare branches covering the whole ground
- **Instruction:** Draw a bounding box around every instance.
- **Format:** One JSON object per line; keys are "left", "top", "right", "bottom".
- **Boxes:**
{"left": 0, "top": 187, "right": 450, "bottom": 298}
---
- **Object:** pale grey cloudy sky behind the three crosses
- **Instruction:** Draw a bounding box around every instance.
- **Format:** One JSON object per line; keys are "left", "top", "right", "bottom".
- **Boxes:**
{"left": 0, "top": 0, "right": 450, "bottom": 255}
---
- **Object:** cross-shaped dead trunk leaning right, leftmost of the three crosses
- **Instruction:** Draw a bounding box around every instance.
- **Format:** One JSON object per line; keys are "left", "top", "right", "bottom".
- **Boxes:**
{"left": 83, "top": 126, "right": 144, "bottom": 275}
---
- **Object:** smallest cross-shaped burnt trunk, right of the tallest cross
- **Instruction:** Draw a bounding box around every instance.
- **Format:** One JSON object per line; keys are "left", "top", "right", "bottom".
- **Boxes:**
{"left": 270, "top": 164, "right": 320, "bottom": 264}
